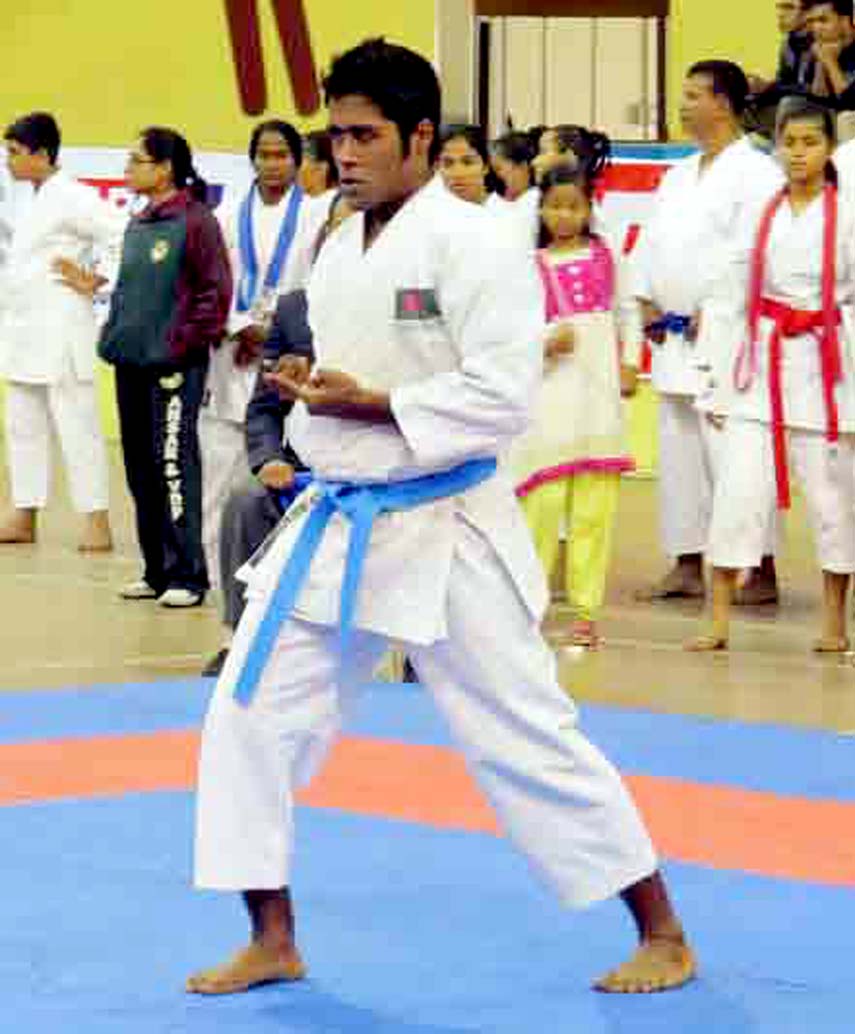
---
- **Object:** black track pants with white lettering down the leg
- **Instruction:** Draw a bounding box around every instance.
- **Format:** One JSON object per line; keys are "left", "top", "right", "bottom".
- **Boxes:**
{"left": 116, "top": 365, "right": 208, "bottom": 595}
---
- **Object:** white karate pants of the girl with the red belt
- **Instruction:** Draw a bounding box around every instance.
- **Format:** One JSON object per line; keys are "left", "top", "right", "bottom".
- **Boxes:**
{"left": 708, "top": 418, "right": 855, "bottom": 574}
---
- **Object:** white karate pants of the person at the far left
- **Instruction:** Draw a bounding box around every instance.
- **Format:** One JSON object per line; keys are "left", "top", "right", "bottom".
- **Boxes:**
{"left": 5, "top": 370, "right": 109, "bottom": 514}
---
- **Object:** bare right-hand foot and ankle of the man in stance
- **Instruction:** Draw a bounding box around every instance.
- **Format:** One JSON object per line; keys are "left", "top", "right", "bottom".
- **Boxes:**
{"left": 594, "top": 873, "right": 697, "bottom": 995}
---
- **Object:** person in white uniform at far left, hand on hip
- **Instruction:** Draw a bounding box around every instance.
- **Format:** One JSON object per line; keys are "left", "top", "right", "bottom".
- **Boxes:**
{"left": 0, "top": 112, "right": 124, "bottom": 552}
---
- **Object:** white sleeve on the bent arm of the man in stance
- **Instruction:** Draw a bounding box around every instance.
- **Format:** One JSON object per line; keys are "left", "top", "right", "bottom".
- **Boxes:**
{"left": 392, "top": 226, "right": 544, "bottom": 468}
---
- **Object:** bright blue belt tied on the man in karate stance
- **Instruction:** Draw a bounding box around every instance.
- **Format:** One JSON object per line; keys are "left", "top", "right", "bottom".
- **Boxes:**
{"left": 235, "top": 459, "right": 496, "bottom": 705}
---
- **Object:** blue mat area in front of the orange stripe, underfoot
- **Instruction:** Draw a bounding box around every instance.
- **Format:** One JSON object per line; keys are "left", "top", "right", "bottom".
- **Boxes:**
{"left": 0, "top": 793, "right": 855, "bottom": 1034}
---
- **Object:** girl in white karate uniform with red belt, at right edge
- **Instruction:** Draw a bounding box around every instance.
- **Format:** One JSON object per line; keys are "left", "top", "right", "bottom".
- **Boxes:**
{"left": 686, "top": 97, "right": 855, "bottom": 653}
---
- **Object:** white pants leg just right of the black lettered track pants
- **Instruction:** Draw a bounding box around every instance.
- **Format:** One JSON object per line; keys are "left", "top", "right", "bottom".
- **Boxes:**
{"left": 199, "top": 406, "right": 250, "bottom": 590}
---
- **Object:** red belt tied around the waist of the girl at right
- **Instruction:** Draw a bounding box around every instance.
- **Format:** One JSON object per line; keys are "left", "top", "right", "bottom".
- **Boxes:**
{"left": 760, "top": 298, "right": 843, "bottom": 510}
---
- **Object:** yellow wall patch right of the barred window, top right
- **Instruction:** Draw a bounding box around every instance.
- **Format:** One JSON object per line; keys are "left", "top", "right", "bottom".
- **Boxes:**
{"left": 667, "top": 0, "right": 780, "bottom": 138}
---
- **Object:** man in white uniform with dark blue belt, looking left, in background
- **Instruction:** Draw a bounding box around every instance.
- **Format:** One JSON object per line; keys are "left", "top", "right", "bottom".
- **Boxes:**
{"left": 631, "top": 60, "right": 783, "bottom": 603}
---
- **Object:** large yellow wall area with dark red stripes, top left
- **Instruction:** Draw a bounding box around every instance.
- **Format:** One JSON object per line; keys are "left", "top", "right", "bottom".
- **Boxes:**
{"left": 0, "top": 0, "right": 434, "bottom": 151}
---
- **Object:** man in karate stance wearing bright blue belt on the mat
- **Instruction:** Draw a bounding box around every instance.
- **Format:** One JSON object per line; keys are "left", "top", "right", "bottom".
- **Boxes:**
{"left": 188, "top": 40, "right": 694, "bottom": 994}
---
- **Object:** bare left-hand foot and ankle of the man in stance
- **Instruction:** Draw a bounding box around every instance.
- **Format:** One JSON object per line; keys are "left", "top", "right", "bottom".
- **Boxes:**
{"left": 187, "top": 887, "right": 306, "bottom": 995}
